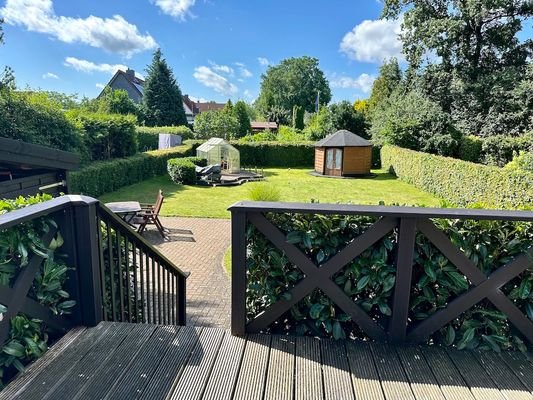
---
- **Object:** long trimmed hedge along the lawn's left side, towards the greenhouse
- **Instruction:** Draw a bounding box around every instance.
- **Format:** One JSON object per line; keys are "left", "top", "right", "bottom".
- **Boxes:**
{"left": 69, "top": 145, "right": 192, "bottom": 197}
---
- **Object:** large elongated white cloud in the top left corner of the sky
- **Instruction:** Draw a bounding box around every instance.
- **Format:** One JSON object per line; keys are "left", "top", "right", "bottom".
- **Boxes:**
{"left": 0, "top": 0, "right": 157, "bottom": 57}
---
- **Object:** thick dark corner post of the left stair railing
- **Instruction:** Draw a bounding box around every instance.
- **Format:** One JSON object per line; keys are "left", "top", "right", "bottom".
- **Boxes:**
{"left": 73, "top": 200, "right": 103, "bottom": 326}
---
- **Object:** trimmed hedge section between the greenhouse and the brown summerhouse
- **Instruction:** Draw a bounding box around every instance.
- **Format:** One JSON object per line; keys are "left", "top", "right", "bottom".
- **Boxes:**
{"left": 232, "top": 141, "right": 315, "bottom": 167}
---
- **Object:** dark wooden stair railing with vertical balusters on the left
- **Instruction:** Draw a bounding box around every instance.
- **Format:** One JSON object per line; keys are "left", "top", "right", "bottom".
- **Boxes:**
{"left": 0, "top": 195, "right": 188, "bottom": 336}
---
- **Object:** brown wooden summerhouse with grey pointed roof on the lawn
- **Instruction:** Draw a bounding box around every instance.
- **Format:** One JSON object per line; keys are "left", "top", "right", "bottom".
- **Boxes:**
{"left": 315, "top": 130, "right": 372, "bottom": 176}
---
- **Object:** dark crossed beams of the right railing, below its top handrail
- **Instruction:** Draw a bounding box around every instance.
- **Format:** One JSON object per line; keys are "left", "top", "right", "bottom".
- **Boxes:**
{"left": 232, "top": 203, "right": 533, "bottom": 343}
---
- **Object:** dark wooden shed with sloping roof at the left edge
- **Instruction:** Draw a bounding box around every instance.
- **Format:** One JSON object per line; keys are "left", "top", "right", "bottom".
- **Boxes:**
{"left": 0, "top": 137, "right": 80, "bottom": 199}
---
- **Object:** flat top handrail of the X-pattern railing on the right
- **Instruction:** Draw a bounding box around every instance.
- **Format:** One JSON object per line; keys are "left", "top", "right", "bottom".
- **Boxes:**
{"left": 228, "top": 201, "right": 533, "bottom": 221}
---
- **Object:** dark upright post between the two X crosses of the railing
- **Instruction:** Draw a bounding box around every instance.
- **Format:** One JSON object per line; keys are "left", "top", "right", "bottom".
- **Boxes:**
{"left": 389, "top": 218, "right": 416, "bottom": 344}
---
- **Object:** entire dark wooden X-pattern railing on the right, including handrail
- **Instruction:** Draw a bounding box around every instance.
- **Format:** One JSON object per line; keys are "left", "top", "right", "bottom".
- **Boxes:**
{"left": 230, "top": 202, "right": 533, "bottom": 343}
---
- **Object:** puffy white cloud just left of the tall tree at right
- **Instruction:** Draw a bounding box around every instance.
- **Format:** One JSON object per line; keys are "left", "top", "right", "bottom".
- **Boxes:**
{"left": 340, "top": 17, "right": 403, "bottom": 63}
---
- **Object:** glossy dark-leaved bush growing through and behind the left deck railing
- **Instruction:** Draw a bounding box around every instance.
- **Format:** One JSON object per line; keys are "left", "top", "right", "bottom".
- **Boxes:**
{"left": 0, "top": 195, "right": 76, "bottom": 387}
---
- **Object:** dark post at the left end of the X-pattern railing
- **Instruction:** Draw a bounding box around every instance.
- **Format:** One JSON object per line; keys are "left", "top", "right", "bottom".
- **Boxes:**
{"left": 231, "top": 210, "right": 246, "bottom": 336}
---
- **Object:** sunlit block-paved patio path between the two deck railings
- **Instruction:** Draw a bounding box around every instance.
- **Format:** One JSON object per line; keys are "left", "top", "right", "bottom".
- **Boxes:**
{"left": 144, "top": 217, "right": 231, "bottom": 329}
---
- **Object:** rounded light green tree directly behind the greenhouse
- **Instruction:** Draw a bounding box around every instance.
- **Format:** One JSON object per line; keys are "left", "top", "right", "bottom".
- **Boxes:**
{"left": 194, "top": 110, "right": 239, "bottom": 140}
